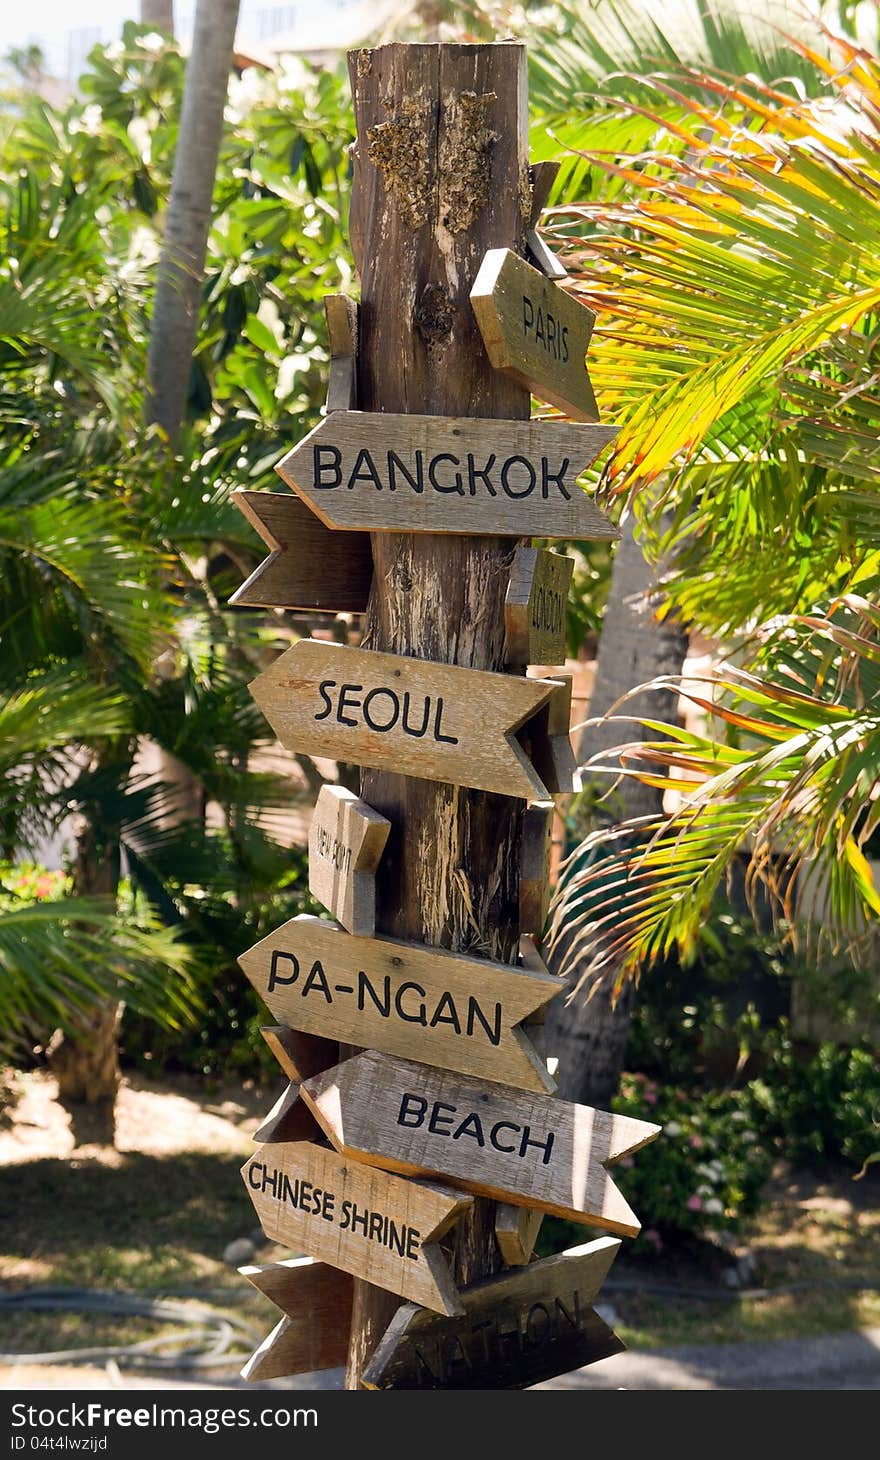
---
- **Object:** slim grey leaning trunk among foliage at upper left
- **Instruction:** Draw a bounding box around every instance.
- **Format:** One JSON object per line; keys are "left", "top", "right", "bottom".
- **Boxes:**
{"left": 147, "top": 0, "right": 239, "bottom": 444}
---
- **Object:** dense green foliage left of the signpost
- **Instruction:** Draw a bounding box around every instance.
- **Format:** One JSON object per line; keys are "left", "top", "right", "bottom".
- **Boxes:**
{"left": 0, "top": 25, "right": 360, "bottom": 1063}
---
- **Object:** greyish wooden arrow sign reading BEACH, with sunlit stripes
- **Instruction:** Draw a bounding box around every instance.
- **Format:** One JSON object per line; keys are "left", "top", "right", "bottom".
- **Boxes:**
{"left": 302, "top": 1050, "right": 660, "bottom": 1237}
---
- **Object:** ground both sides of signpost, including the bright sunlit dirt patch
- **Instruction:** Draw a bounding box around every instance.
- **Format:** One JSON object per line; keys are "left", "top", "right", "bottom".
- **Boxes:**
{"left": 0, "top": 1072, "right": 880, "bottom": 1388}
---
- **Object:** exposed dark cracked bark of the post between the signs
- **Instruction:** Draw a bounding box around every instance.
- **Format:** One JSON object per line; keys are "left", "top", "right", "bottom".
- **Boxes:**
{"left": 347, "top": 42, "right": 531, "bottom": 1388}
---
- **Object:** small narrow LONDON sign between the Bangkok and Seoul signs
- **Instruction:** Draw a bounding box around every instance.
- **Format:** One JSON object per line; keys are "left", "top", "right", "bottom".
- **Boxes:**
{"left": 503, "top": 548, "right": 575, "bottom": 666}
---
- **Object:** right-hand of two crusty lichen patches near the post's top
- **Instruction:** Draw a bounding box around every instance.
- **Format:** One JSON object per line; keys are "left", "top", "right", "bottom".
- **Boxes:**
{"left": 438, "top": 92, "right": 498, "bottom": 234}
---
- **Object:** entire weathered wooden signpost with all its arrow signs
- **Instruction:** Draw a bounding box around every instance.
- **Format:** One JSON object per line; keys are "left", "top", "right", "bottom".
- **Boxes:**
{"left": 236, "top": 42, "right": 657, "bottom": 1388}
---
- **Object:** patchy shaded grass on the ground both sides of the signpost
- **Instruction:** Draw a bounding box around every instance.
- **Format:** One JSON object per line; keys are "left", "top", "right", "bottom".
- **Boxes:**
{"left": 0, "top": 1074, "right": 880, "bottom": 1371}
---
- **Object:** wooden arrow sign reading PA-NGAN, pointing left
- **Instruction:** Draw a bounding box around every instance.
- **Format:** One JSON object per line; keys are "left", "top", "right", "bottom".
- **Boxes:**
{"left": 239, "top": 914, "right": 563, "bottom": 1091}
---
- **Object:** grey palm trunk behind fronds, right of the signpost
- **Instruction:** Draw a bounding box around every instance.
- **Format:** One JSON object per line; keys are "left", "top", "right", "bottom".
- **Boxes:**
{"left": 547, "top": 517, "right": 687, "bottom": 1107}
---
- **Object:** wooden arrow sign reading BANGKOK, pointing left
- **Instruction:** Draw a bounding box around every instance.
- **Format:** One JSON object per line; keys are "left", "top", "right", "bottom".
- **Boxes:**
{"left": 276, "top": 410, "right": 620, "bottom": 539}
